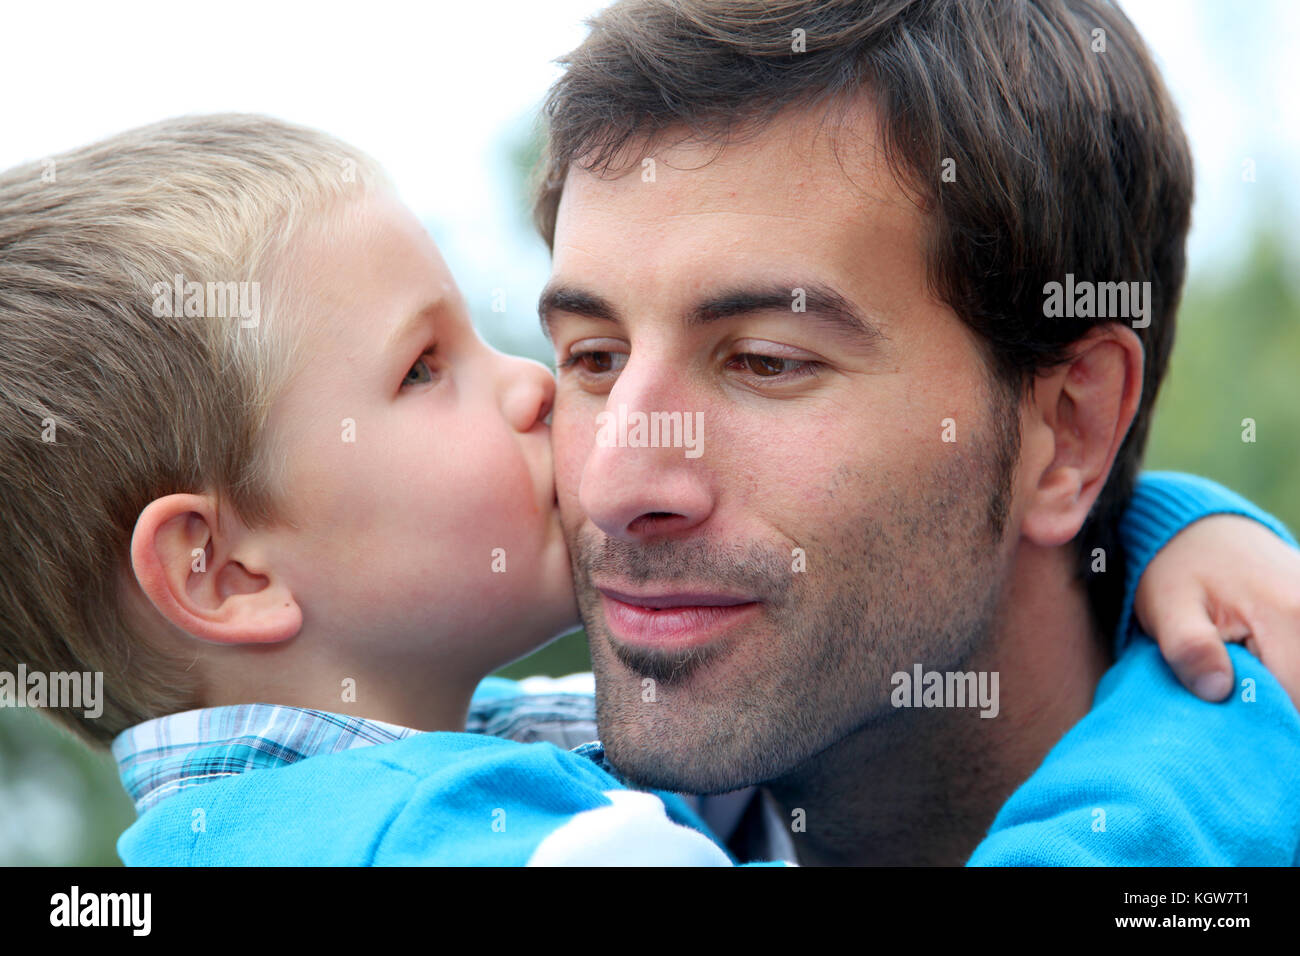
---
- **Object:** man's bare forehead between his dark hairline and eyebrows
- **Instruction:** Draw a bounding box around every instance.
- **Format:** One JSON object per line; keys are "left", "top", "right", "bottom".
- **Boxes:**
{"left": 543, "top": 109, "right": 926, "bottom": 329}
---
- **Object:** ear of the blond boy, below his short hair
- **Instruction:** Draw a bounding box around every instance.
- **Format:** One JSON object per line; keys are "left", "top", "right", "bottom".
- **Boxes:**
{"left": 131, "top": 494, "right": 303, "bottom": 644}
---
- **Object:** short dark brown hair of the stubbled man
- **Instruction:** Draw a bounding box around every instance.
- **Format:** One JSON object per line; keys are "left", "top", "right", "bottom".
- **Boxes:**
{"left": 534, "top": 0, "right": 1192, "bottom": 635}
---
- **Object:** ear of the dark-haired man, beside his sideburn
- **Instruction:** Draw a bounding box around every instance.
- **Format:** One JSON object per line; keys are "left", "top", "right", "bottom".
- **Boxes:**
{"left": 1021, "top": 323, "right": 1143, "bottom": 548}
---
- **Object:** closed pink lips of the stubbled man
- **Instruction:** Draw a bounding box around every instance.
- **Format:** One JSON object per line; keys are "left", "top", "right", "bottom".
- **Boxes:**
{"left": 598, "top": 588, "right": 758, "bottom": 650}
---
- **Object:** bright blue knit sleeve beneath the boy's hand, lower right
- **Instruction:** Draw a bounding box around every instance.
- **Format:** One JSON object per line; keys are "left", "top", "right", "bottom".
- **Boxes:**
{"left": 969, "top": 636, "right": 1300, "bottom": 866}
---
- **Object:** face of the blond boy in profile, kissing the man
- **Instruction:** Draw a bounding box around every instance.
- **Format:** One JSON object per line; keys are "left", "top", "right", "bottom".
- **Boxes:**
{"left": 261, "top": 195, "right": 577, "bottom": 680}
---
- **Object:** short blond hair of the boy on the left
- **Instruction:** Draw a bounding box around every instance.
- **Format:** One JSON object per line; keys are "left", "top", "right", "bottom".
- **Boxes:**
{"left": 0, "top": 114, "right": 386, "bottom": 744}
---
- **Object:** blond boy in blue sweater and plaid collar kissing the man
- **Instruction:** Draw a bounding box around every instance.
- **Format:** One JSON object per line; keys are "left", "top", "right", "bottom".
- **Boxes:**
{"left": 0, "top": 116, "right": 1282, "bottom": 865}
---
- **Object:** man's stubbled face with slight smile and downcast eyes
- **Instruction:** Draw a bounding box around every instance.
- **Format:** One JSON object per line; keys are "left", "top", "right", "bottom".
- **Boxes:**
{"left": 542, "top": 100, "right": 1018, "bottom": 792}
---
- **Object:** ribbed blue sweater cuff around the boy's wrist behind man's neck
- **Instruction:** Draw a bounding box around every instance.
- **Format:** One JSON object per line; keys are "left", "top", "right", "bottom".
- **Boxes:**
{"left": 1115, "top": 471, "right": 1296, "bottom": 656}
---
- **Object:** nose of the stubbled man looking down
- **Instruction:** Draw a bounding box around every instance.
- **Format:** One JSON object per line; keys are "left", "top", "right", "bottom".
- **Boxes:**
{"left": 579, "top": 359, "right": 714, "bottom": 541}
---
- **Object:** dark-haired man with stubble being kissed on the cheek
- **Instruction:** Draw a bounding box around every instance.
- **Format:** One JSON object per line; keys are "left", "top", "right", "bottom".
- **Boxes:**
{"left": 517, "top": 0, "right": 1300, "bottom": 864}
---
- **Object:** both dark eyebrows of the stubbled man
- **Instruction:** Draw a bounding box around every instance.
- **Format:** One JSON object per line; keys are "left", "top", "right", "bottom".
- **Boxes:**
{"left": 537, "top": 282, "right": 885, "bottom": 345}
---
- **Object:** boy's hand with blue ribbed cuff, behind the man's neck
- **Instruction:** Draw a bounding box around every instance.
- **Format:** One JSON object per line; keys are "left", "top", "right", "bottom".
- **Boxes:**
{"left": 1117, "top": 472, "right": 1300, "bottom": 708}
